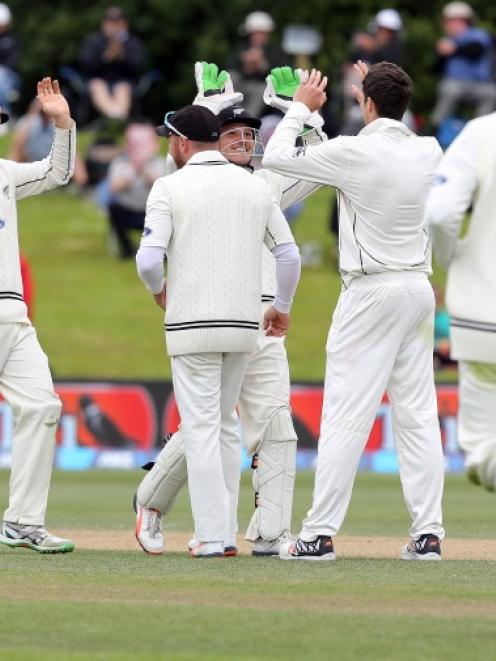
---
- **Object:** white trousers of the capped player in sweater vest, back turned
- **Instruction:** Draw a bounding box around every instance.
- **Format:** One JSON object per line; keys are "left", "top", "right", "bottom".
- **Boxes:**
{"left": 172, "top": 353, "right": 250, "bottom": 542}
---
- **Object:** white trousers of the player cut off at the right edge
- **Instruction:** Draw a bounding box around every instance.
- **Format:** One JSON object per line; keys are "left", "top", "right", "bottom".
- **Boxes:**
{"left": 458, "top": 360, "right": 496, "bottom": 467}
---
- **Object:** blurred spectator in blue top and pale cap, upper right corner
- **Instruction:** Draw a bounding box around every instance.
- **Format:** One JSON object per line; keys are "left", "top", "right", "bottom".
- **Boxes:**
{"left": 432, "top": 2, "right": 496, "bottom": 127}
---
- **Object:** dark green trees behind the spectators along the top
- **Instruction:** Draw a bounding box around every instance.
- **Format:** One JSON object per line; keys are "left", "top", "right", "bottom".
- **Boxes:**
{"left": 8, "top": 0, "right": 496, "bottom": 121}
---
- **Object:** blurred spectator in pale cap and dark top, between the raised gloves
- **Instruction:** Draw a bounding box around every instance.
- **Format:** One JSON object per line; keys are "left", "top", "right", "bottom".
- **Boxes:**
{"left": 227, "top": 11, "right": 287, "bottom": 117}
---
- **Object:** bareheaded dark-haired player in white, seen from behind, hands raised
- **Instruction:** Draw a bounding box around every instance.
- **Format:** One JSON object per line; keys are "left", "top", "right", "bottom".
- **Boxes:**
{"left": 263, "top": 62, "right": 444, "bottom": 560}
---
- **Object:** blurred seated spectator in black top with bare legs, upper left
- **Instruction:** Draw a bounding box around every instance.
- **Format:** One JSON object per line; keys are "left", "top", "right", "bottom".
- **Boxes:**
{"left": 79, "top": 7, "right": 145, "bottom": 119}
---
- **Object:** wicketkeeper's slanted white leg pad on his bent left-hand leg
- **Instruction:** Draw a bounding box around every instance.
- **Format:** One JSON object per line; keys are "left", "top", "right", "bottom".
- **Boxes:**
{"left": 137, "top": 430, "right": 188, "bottom": 515}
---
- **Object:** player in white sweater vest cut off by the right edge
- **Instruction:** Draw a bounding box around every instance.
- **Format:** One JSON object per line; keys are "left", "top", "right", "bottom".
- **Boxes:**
{"left": 426, "top": 113, "right": 496, "bottom": 491}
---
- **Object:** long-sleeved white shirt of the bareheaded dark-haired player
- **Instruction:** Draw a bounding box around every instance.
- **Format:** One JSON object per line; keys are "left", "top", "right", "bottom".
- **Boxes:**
{"left": 262, "top": 102, "right": 442, "bottom": 285}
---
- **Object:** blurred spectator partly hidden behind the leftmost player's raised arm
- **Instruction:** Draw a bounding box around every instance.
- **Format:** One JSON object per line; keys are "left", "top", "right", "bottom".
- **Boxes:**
{"left": 9, "top": 99, "right": 88, "bottom": 187}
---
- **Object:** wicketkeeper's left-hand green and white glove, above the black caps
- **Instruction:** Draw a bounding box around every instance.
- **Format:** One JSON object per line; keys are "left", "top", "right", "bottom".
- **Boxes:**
{"left": 193, "top": 62, "right": 243, "bottom": 115}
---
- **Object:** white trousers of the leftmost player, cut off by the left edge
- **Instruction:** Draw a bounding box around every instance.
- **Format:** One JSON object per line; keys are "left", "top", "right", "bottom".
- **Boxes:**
{"left": 0, "top": 323, "right": 61, "bottom": 525}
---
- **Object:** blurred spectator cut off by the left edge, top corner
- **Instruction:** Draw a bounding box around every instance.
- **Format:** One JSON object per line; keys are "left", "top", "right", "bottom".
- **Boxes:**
{"left": 0, "top": 3, "right": 21, "bottom": 112}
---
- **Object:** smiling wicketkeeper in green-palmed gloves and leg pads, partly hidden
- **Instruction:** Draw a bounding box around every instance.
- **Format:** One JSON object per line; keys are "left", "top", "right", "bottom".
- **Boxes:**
{"left": 136, "top": 62, "right": 325, "bottom": 556}
